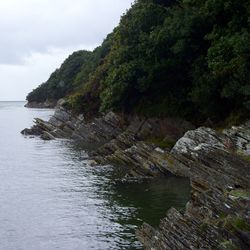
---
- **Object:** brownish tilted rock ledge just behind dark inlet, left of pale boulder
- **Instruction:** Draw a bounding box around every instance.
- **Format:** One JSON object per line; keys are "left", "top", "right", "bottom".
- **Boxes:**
{"left": 91, "top": 118, "right": 192, "bottom": 176}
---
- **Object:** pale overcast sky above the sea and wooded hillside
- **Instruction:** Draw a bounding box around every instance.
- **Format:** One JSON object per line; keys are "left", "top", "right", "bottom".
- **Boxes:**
{"left": 0, "top": 0, "right": 134, "bottom": 101}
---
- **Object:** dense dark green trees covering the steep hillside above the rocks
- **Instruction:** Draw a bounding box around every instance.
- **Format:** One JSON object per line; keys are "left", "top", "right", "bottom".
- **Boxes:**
{"left": 27, "top": 0, "right": 250, "bottom": 121}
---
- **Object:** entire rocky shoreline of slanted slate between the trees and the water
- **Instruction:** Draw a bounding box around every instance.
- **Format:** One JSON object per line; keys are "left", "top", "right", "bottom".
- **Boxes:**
{"left": 22, "top": 107, "right": 250, "bottom": 250}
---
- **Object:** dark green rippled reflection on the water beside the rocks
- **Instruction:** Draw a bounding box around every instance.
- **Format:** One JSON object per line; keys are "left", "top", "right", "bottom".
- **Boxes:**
{"left": 53, "top": 141, "right": 190, "bottom": 249}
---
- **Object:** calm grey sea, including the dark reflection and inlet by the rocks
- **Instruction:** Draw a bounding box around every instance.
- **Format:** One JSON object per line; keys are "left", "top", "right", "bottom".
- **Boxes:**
{"left": 0, "top": 102, "right": 189, "bottom": 250}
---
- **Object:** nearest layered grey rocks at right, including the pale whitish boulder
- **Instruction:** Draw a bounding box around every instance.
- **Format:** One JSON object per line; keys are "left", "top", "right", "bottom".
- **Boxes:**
{"left": 137, "top": 123, "right": 250, "bottom": 250}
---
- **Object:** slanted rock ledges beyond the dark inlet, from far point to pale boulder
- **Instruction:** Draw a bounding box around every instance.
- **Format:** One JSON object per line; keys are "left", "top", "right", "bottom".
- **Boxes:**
{"left": 22, "top": 107, "right": 193, "bottom": 176}
